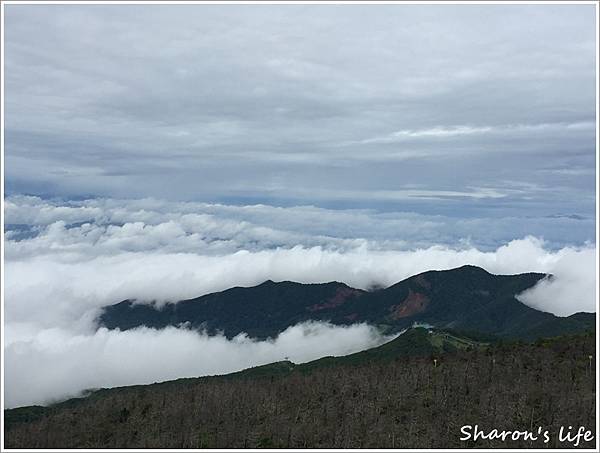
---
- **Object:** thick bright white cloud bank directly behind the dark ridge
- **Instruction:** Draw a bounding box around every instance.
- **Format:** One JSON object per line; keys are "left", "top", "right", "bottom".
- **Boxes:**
{"left": 5, "top": 237, "right": 596, "bottom": 332}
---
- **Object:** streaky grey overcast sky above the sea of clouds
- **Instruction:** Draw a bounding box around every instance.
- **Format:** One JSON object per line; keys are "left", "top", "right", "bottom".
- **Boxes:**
{"left": 5, "top": 5, "right": 595, "bottom": 220}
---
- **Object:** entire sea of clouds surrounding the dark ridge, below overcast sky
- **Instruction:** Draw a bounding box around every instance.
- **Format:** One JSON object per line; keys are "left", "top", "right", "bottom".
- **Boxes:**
{"left": 4, "top": 196, "right": 597, "bottom": 407}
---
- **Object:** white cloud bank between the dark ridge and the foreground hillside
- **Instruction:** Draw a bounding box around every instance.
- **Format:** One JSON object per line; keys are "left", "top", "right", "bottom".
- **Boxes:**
{"left": 5, "top": 322, "right": 391, "bottom": 407}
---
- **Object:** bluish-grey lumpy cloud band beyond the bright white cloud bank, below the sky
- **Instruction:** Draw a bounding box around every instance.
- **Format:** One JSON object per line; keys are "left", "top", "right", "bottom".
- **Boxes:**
{"left": 5, "top": 196, "right": 595, "bottom": 252}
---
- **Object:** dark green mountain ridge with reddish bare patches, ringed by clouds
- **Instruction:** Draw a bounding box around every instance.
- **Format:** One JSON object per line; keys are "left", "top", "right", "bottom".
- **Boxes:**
{"left": 98, "top": 266, "right": 595, "bottom": 339}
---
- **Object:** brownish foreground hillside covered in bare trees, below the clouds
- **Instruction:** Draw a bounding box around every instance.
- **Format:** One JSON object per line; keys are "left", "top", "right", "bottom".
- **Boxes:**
{"left": 5, "top": 329, "right": 595, "bottom": 448}
